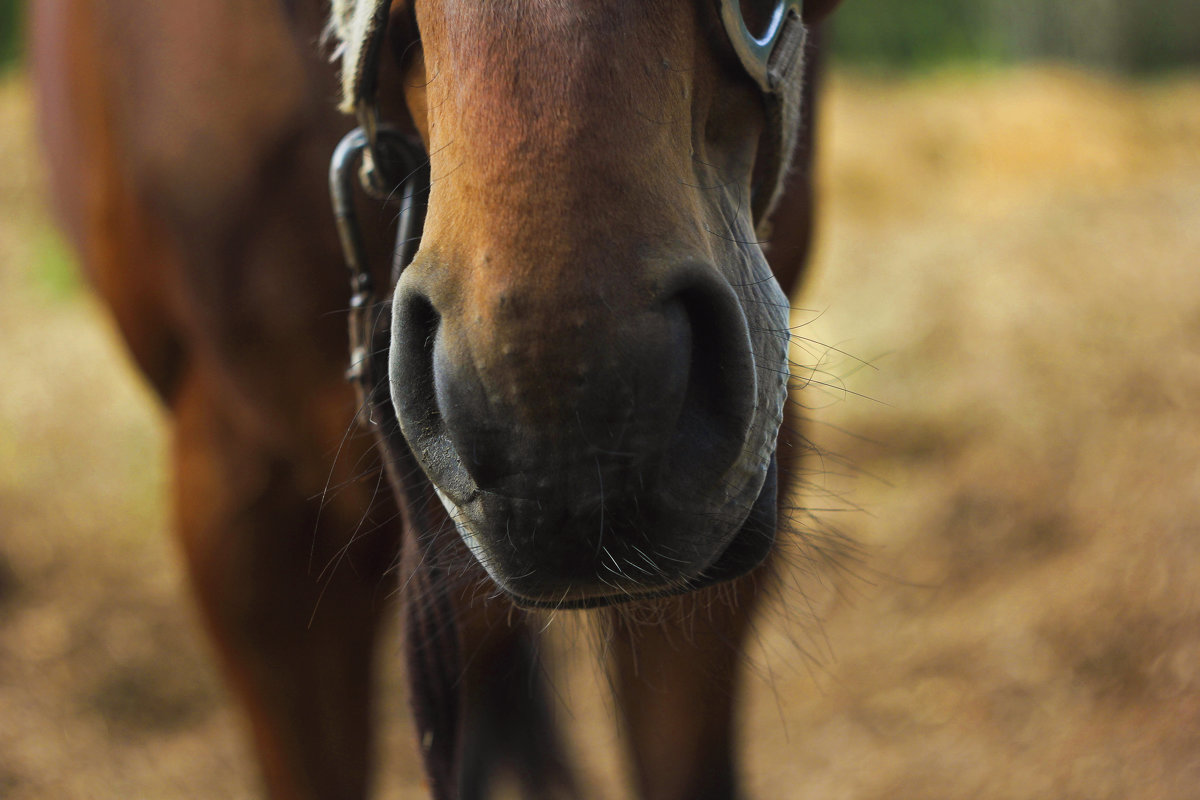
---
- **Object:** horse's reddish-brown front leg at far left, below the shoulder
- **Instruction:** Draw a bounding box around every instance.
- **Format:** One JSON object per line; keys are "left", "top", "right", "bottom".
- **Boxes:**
{"left": 173, "top": 371, "right": 398, "bottom": 800}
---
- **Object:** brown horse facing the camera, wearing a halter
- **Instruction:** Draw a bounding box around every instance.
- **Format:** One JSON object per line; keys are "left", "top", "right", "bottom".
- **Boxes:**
{"left": 30, "top": 0, "right": 836, "bottom": 800}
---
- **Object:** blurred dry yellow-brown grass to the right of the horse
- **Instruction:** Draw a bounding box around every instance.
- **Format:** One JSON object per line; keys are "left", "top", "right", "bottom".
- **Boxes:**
{"left": 757, "top": 71, "right": 1200, "bottom": 799}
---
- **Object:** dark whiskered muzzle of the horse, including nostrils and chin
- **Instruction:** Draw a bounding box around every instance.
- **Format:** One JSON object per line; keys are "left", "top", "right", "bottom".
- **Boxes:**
{"left": 390, "top": 244, "right": 779, "bottom": 607}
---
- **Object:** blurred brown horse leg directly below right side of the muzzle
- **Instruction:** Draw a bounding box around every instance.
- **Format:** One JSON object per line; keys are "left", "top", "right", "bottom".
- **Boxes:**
{"left": 612, "top": 578, "right": 757, "bottom": 800}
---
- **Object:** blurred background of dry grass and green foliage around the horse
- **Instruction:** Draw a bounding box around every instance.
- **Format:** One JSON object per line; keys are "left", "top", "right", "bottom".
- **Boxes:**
{"left": 0, "top": 0, "right": 1200, "bottom": 800}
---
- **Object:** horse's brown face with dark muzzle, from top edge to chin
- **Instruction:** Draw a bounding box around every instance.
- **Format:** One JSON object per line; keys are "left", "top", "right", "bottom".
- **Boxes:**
{"left": 389, "top": 0, "right": 787, "bottom": 607}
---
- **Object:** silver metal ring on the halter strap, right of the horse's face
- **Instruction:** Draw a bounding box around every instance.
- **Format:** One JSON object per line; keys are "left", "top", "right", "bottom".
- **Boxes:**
{"left": 716, "top": 0, "right": 808, "bottom": 94}
